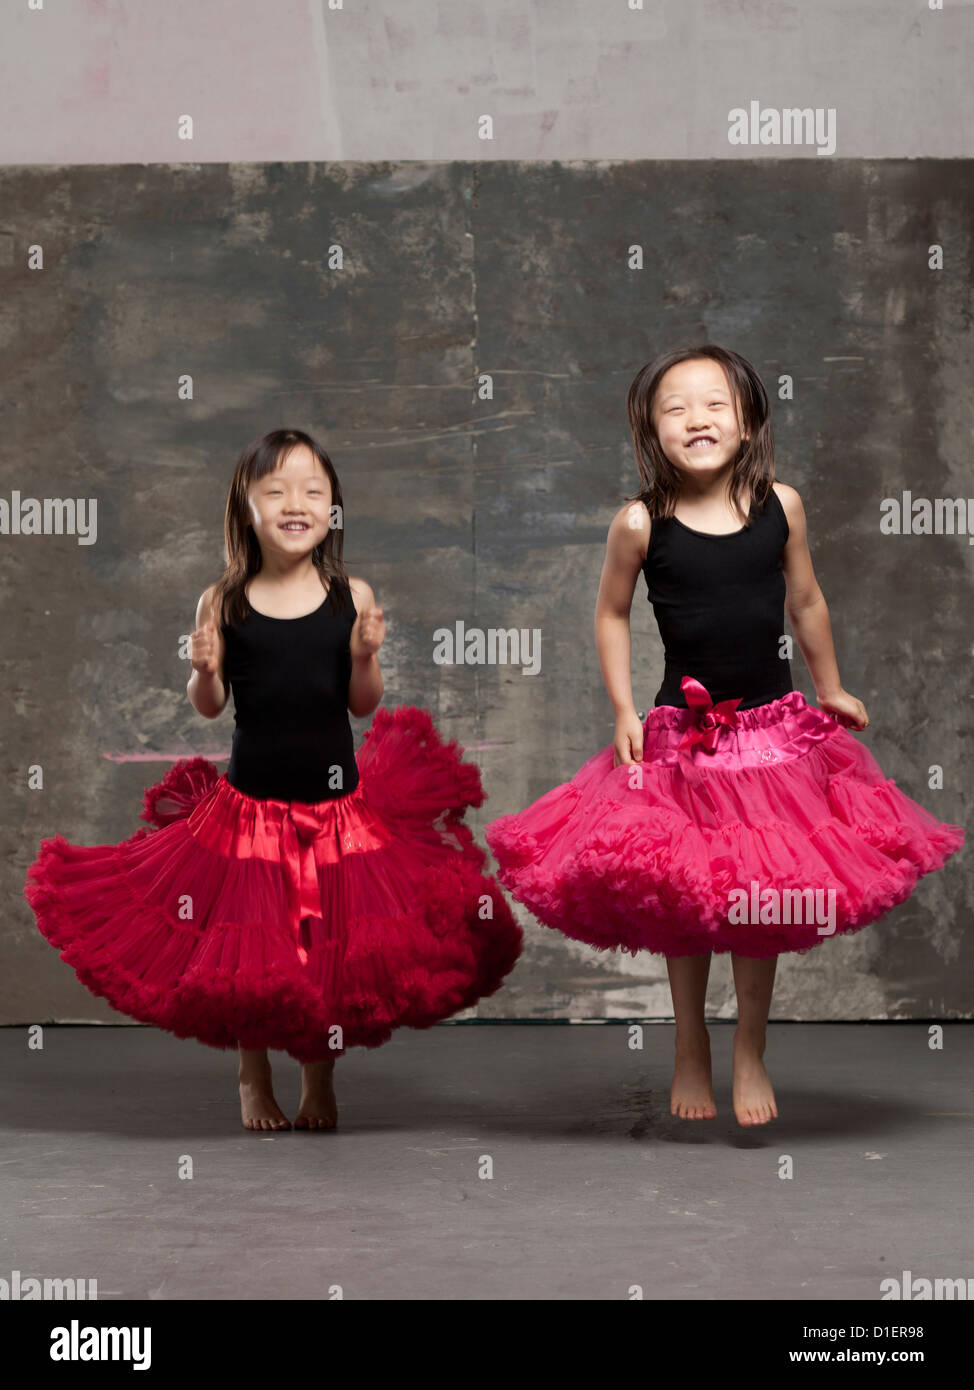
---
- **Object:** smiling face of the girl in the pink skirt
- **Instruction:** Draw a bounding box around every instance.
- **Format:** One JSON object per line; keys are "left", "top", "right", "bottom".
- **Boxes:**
{"left": 652, "top": 357, "right": 743, "bottom": 475}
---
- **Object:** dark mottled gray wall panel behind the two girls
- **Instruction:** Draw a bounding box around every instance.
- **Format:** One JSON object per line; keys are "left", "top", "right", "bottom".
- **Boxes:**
{"left": 0, "top": 160, "right": 974, "bottom": 1023}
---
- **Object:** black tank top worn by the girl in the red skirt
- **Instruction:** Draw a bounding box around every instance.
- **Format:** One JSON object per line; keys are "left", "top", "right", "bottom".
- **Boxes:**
{"left": 224, "top": 581, "right": 358, "bottom": 801}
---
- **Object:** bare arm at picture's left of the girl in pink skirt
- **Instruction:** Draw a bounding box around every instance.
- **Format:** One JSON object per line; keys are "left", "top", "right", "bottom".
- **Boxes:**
{"left": 595, "top": 502, "right": 650, "bottom": 767}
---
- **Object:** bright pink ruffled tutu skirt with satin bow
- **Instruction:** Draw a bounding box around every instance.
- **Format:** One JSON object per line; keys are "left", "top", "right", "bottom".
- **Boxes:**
{"left": 485, "top": 682, "right": 964, "bottom": 958}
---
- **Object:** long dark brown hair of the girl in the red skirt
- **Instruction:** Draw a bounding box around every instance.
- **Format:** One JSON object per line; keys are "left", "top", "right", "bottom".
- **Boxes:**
{"left": 213, "top": 430, "right": 352, "bottom": 626}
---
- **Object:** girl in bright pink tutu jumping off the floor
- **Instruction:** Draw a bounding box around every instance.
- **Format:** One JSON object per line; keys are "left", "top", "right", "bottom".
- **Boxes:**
{"left": 486, "top": 345, "right": 964, "bottom": 1125}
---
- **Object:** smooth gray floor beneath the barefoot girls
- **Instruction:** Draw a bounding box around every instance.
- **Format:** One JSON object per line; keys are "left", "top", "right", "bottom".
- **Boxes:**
{"left": 0, "top": 1023, "right": 974, "bottom": 1300}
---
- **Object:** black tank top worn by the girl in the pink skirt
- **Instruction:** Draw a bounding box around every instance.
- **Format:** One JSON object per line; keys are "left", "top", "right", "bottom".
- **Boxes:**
{"left": 642, "top": 489, "right": 793, "bottom": 709}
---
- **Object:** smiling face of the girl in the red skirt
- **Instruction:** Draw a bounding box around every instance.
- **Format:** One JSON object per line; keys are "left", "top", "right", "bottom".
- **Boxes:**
{"left": 247, "top": 445, "right": 332, "bottom": 556}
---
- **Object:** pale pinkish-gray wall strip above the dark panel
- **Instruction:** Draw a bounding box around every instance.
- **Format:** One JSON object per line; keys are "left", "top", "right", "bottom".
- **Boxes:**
{"left": 0, "top": 0, "right": 974, "bottom": 164}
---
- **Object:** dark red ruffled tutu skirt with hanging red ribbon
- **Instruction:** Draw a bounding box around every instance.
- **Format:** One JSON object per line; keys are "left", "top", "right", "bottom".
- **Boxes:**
{"left": 24, "top": 706, "right": 522, "bottom": 1062}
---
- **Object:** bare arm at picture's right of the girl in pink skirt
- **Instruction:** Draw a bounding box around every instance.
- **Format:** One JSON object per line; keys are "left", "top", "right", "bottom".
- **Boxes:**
{"left": 774, "top": 482, "right": 868, "bottom": 728}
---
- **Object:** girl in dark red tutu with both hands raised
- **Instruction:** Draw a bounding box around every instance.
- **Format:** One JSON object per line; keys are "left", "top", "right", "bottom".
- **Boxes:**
{"left": 25, "top": 430, "right": 521, "bottom": 1130}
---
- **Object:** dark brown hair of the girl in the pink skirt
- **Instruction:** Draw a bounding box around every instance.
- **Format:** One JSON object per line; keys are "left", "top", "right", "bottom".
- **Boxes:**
{"left": 625, "top": 343, "right": 774, "bottom": 525}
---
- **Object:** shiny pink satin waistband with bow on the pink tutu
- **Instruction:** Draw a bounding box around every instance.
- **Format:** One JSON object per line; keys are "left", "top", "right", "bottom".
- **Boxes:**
{"left": 643, "top": 677, "right": 839, "bottom": 771}
